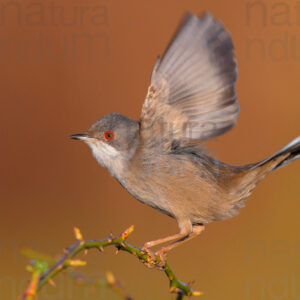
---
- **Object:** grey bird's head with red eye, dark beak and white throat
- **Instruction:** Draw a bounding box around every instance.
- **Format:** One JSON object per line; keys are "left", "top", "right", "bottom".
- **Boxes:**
{"left": 70, "top": 113, "right": 139, "bottom": 176}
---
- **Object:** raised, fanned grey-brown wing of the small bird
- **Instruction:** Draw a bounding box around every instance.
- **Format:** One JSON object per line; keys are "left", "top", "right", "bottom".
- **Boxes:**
{"left": 140, "top": 13, "right": 239, "bottom": 151}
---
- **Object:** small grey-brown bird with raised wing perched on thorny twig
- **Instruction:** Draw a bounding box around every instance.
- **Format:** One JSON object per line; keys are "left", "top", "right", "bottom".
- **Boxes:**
{"left": 70, "top": 13, "right": 300, "bottom": 261}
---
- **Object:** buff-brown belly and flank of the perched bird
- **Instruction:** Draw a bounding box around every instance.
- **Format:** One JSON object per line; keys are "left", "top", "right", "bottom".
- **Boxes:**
{"left": 119, "top": 157, "right": 239, "bottom": 223}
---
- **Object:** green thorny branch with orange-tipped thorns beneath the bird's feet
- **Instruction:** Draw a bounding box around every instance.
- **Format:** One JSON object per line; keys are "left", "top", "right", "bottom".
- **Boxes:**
{"left": 23, "top": 226, "right": 202, "bottom": 300}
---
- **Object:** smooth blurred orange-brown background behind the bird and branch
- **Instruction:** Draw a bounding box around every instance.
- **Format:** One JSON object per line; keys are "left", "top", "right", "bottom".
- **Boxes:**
{"left": 0, "top": 0, "right": 300, "bottom": 300}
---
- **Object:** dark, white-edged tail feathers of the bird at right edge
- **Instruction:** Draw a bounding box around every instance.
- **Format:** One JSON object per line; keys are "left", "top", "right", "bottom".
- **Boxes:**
{"left": 255, "top": 136, "right": 300, "bottom": 171}
